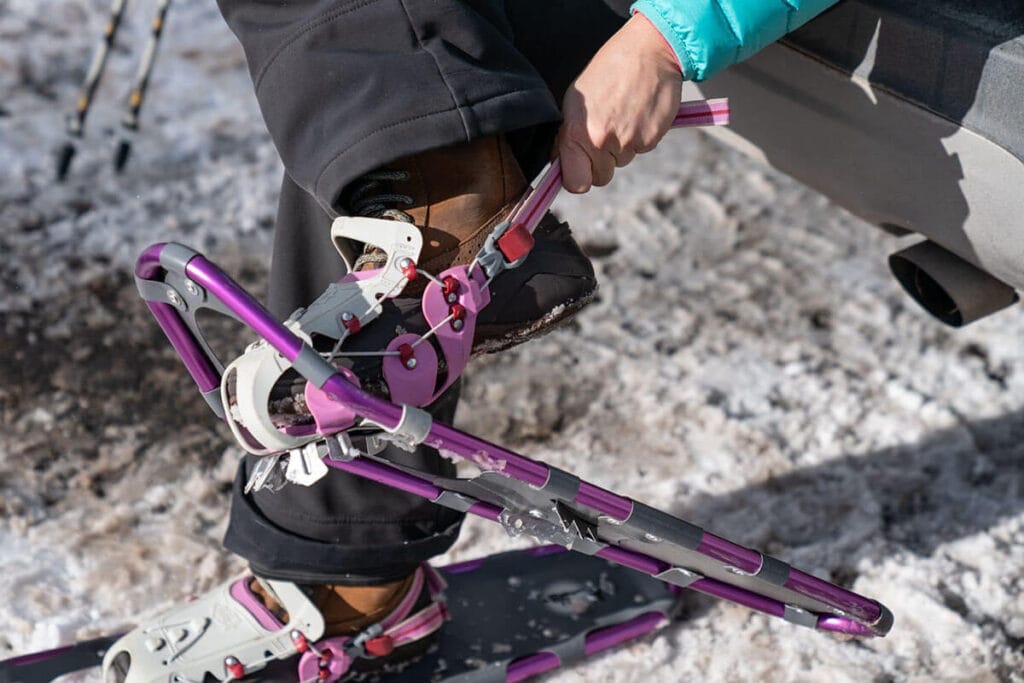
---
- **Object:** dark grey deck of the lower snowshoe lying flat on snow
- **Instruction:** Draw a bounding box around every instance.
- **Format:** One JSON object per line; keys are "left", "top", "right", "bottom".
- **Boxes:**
{"left": 0, "top": 546, "right": 678, "bottom": 683}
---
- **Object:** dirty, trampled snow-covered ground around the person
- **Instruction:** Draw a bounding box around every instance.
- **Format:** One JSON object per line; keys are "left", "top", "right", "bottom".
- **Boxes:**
{"left": 0, "top": 0, "right": 1024, "bottom": 682}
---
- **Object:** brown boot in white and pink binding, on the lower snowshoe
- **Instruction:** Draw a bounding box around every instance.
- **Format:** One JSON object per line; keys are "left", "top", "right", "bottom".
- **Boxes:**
{"left": 103, "top": 564, "right": 449, "bottom": 683}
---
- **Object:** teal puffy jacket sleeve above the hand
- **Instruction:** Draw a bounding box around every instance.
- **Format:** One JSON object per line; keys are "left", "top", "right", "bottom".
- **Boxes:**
{"left": 630, "top": 0, "right": 837, "bottom": 81}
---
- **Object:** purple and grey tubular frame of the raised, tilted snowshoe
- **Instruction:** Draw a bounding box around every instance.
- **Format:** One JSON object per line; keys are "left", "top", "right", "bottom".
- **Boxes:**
{"left": 135, "top": 100, "right": 893, "bottom": 637}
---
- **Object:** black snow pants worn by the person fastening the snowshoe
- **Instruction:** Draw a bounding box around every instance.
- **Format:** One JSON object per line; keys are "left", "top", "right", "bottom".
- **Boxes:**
{"left": 218, "top": 0, "right": 629, "bottom": 584}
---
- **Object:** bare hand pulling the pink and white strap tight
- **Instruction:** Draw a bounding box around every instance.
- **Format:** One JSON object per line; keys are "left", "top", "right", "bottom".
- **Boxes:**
{"left": 555, "top": 14, "right": 683, "bottom": 194}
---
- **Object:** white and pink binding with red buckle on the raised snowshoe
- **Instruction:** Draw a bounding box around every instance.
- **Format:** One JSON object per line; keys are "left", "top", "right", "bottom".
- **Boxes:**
{"left": 218, "top": 101, "right": 728, "bottom": 454}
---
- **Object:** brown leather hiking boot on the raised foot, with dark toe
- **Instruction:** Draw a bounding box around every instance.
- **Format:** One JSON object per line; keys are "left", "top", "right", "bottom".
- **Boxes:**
{"left": 272, "top": 136, "right": 597, "bottom": 401}
